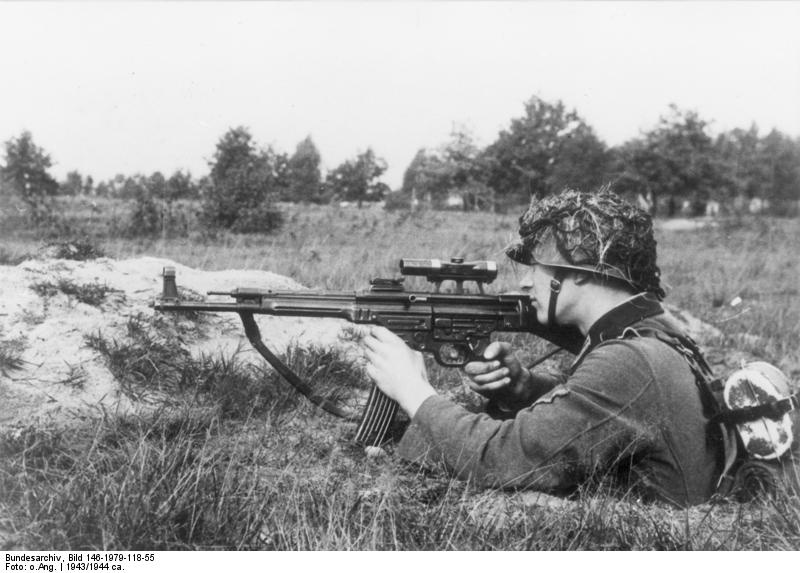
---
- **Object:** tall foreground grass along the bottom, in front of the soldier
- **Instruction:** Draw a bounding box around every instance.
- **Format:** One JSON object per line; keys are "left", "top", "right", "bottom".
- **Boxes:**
{"left": 0, "top": 416, "right": 800, "bottom": 550}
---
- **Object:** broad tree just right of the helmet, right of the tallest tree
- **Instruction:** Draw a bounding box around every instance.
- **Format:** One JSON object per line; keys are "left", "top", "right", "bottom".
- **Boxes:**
{"left": 615, "top": 105, "right": 729, "bottom": 215}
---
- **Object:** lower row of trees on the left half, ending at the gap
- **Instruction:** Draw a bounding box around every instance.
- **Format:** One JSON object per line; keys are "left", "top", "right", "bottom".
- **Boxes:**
{"left": 0, "top": 126, "right": 390, "bottom": 235}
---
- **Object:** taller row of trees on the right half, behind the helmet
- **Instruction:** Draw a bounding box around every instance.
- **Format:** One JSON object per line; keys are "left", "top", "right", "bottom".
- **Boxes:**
{"left": 401, "top": 97, "right": 800, "bottom": 216}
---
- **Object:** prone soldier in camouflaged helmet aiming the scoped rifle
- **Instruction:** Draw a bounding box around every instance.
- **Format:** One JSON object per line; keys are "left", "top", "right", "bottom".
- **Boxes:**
{"left": 364, "top": 191, "right": 725, "bottom": 506}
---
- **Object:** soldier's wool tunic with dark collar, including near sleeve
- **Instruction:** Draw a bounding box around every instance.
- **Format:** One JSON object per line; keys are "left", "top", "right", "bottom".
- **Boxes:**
{"left": 399, "top": 295, "right": 723, "bottom": 505}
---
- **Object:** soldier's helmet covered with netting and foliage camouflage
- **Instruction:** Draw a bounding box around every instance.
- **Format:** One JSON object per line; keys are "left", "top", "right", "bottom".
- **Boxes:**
{"left": 506, "top": 190, "right": 665, "bottom": 299}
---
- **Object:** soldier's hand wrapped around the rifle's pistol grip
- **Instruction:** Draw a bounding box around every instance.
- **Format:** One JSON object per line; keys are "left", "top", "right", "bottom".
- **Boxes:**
{"left": 464, "top": 341, "right": 531, "bottom": 402}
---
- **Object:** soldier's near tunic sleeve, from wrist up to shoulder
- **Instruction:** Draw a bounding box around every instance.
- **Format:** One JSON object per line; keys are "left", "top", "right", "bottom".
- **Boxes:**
{"left": 399, "top": 341, "right": 658, "bottom": 491}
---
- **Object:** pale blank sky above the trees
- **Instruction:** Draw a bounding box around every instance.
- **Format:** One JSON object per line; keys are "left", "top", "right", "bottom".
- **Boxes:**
{"left": 0, "top": 1, "right": 800, "bottom": 186}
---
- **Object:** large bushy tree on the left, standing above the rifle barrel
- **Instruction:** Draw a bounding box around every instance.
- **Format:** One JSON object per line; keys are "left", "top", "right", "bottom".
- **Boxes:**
{"left": 202, "top": 127, "right": 288, "bottom": 233}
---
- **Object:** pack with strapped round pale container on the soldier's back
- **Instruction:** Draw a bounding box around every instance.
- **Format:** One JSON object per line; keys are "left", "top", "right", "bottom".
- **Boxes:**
{"left": 629, "top": 328, "right": 800, "bottom": 500}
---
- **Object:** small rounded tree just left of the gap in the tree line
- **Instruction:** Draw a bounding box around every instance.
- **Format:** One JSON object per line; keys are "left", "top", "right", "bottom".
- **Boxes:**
{"left": 325, "top": 149, "right": 389, "bottom": 209}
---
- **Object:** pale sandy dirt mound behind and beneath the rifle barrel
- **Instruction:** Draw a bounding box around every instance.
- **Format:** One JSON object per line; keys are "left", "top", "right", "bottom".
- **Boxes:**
{"left": 0, "top": 257, "right": 354, "bottom": 425}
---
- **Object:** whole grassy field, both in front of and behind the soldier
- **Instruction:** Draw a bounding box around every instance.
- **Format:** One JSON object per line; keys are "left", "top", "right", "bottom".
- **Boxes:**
{"left": 0, "top": 200, "right": 800, "bottom": 550}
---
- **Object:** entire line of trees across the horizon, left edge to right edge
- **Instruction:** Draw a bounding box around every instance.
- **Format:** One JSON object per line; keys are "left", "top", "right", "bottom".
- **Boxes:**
{"left": 0, "top": 97, "right": 800, "bottom": 234}
